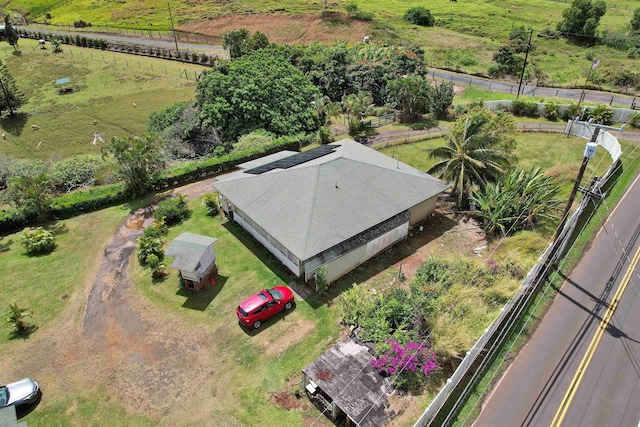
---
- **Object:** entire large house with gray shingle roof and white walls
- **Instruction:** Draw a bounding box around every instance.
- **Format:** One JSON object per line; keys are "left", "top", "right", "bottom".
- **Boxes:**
{"left": 212, "top": 139, "right": 449, "bottom": 282}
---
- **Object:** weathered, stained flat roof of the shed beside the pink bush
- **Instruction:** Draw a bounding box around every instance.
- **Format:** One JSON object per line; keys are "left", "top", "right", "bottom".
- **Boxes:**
{"left": 302, "top": 337, "right": 393, "bottom": 427}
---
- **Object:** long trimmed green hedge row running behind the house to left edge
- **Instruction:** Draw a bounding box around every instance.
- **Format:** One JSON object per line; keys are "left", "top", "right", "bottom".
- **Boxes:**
{"left": 0, "top": 137, "right": 299, "bottom": 235}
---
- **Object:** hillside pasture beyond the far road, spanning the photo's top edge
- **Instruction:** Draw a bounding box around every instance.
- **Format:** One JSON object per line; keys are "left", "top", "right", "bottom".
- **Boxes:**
{"left": 8, "top": 0, "right": 640, "bottom": 90}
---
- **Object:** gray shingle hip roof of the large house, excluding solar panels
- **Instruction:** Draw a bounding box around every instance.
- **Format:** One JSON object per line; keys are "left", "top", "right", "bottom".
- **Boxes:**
{"left": 212, "top": 139, "right": 449, "bottom": 260}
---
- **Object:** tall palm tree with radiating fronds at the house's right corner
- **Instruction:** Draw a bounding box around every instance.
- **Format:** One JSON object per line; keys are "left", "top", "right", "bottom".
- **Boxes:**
{"left": 427, "top": 112, "right": 510, "bottom": 207}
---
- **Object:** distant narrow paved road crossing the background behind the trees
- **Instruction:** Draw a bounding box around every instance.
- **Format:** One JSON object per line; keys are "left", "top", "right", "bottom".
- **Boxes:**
{"left": 21, "top": 26, "right": 640, "bottom": 108}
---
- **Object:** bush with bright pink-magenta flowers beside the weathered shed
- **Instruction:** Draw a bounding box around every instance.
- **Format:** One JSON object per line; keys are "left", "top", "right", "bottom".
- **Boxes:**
{"left": 371, "top": 338, "right": 439, "bottom": 389}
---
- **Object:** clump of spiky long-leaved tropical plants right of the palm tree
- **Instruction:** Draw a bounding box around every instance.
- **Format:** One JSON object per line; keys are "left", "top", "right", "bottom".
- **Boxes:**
{"left": 471, "top": 168, "right": 562, "bottom": 236}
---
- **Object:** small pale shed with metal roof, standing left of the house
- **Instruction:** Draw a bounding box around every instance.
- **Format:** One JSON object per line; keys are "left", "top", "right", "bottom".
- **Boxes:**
{"left": 165, "top": 233, "right": 218, "bottom": 290}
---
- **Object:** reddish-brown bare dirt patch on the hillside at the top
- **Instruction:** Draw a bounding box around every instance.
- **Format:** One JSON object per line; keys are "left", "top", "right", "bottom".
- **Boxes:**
{"left": 179, "top": 13, "right": 370, "bottom": 44}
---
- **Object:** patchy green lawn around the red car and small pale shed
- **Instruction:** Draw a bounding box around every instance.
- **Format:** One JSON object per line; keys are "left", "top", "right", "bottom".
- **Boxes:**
{"left": 130, "top": 199, "right": 341, "bottom": 425}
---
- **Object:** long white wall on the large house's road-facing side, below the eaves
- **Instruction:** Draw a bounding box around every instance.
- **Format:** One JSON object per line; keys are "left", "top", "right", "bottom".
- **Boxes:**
{"left": 320, "top": 222, "right": 409, "bottom": 283}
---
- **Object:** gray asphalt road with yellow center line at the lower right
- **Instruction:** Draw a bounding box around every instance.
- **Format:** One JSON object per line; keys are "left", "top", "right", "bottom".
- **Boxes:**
{"left": 474, "top": 175, "right": 640, "bottom": 427}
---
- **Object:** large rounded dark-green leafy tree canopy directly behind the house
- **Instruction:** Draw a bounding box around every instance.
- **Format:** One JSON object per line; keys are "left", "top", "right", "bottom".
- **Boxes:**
{"left": 196, "top": 49, "right": 319, "bottom": 142}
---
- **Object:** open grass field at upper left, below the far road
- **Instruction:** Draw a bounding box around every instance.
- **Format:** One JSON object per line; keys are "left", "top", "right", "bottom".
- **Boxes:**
{"left": 0, "top": 39, "right": 206, "bottom": 159}
